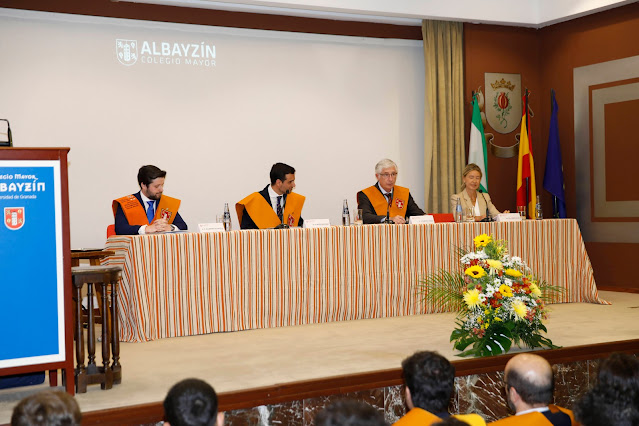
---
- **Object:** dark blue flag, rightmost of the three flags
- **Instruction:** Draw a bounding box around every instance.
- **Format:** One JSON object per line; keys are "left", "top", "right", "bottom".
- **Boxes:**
{"left": 544, "top": 90, "right": 566, "bottom": 218}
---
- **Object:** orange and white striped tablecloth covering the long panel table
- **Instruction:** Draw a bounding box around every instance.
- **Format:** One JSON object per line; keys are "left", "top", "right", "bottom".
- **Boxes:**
{"left": 104, "top": 219, "right": 606, "bottom": 342}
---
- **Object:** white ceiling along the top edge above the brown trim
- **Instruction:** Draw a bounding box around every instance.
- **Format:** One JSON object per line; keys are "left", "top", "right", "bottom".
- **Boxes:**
{"left": 113, "top": 0, "right": 637, "bottom": 28}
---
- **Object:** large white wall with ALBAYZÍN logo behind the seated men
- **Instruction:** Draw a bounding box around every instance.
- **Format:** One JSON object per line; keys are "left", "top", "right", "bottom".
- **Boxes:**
{"left": 0, "top": 9, "right": 428, "bottom": 248}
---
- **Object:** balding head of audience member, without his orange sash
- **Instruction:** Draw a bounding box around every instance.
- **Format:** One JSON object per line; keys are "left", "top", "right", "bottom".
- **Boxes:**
{"left": 504, "top": 353, "right": 554, "bottom": 412}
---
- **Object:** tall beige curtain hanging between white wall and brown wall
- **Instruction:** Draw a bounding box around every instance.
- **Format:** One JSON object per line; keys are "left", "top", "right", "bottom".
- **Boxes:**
{"left": 422, "top": 20, "right": 466, "bottom": 213}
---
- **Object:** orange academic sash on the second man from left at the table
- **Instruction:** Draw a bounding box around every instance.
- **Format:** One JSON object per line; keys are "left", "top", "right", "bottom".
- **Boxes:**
{"left": 235, "top": 192, "right": 306, "bottom": 229}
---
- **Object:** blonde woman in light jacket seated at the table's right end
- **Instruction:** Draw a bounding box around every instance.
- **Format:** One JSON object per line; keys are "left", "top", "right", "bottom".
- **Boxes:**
{"left": 450, "top": 163, "right": 510, "bottom": 221}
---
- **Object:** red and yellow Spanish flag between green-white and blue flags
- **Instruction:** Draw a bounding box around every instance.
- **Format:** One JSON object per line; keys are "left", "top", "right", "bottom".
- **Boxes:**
{"left": 517, "top": 90, "right": 537, "bottom": 219}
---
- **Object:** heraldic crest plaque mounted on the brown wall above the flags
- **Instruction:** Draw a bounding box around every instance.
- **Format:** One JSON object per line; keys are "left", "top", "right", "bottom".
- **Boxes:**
{"left": 484, "top": 72, "right": 522, "bottom": 133}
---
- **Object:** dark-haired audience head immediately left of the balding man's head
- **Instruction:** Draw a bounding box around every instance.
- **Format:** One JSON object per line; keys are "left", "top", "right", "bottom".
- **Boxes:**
{"left": 402, "top": 351, "right": 455, "bottom": 413}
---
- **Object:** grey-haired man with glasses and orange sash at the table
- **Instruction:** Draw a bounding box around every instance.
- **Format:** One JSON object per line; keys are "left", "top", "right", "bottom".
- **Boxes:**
{"left": 357, "top": 158, "right": 425, "bottom": 224}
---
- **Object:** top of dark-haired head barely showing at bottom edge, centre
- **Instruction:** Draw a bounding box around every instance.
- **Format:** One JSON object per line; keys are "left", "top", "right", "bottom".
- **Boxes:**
{"left": 315, "top": 400, "right": 388, "bottom": 426}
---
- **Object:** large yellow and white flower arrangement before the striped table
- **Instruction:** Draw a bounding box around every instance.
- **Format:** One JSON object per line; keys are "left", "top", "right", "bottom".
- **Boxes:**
{"left": 421, "top": 234, "right": 563, "bottom": 357}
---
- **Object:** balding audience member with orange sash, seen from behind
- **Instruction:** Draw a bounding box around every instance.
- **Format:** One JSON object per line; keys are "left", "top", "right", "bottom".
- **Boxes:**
{"left": 489, "top": 353, "right": 578, "bottom": 426}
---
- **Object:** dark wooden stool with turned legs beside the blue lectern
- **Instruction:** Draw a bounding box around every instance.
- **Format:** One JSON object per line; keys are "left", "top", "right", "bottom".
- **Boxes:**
{"left": 71, "top": 266, "right": 122, "bottom": 393}
